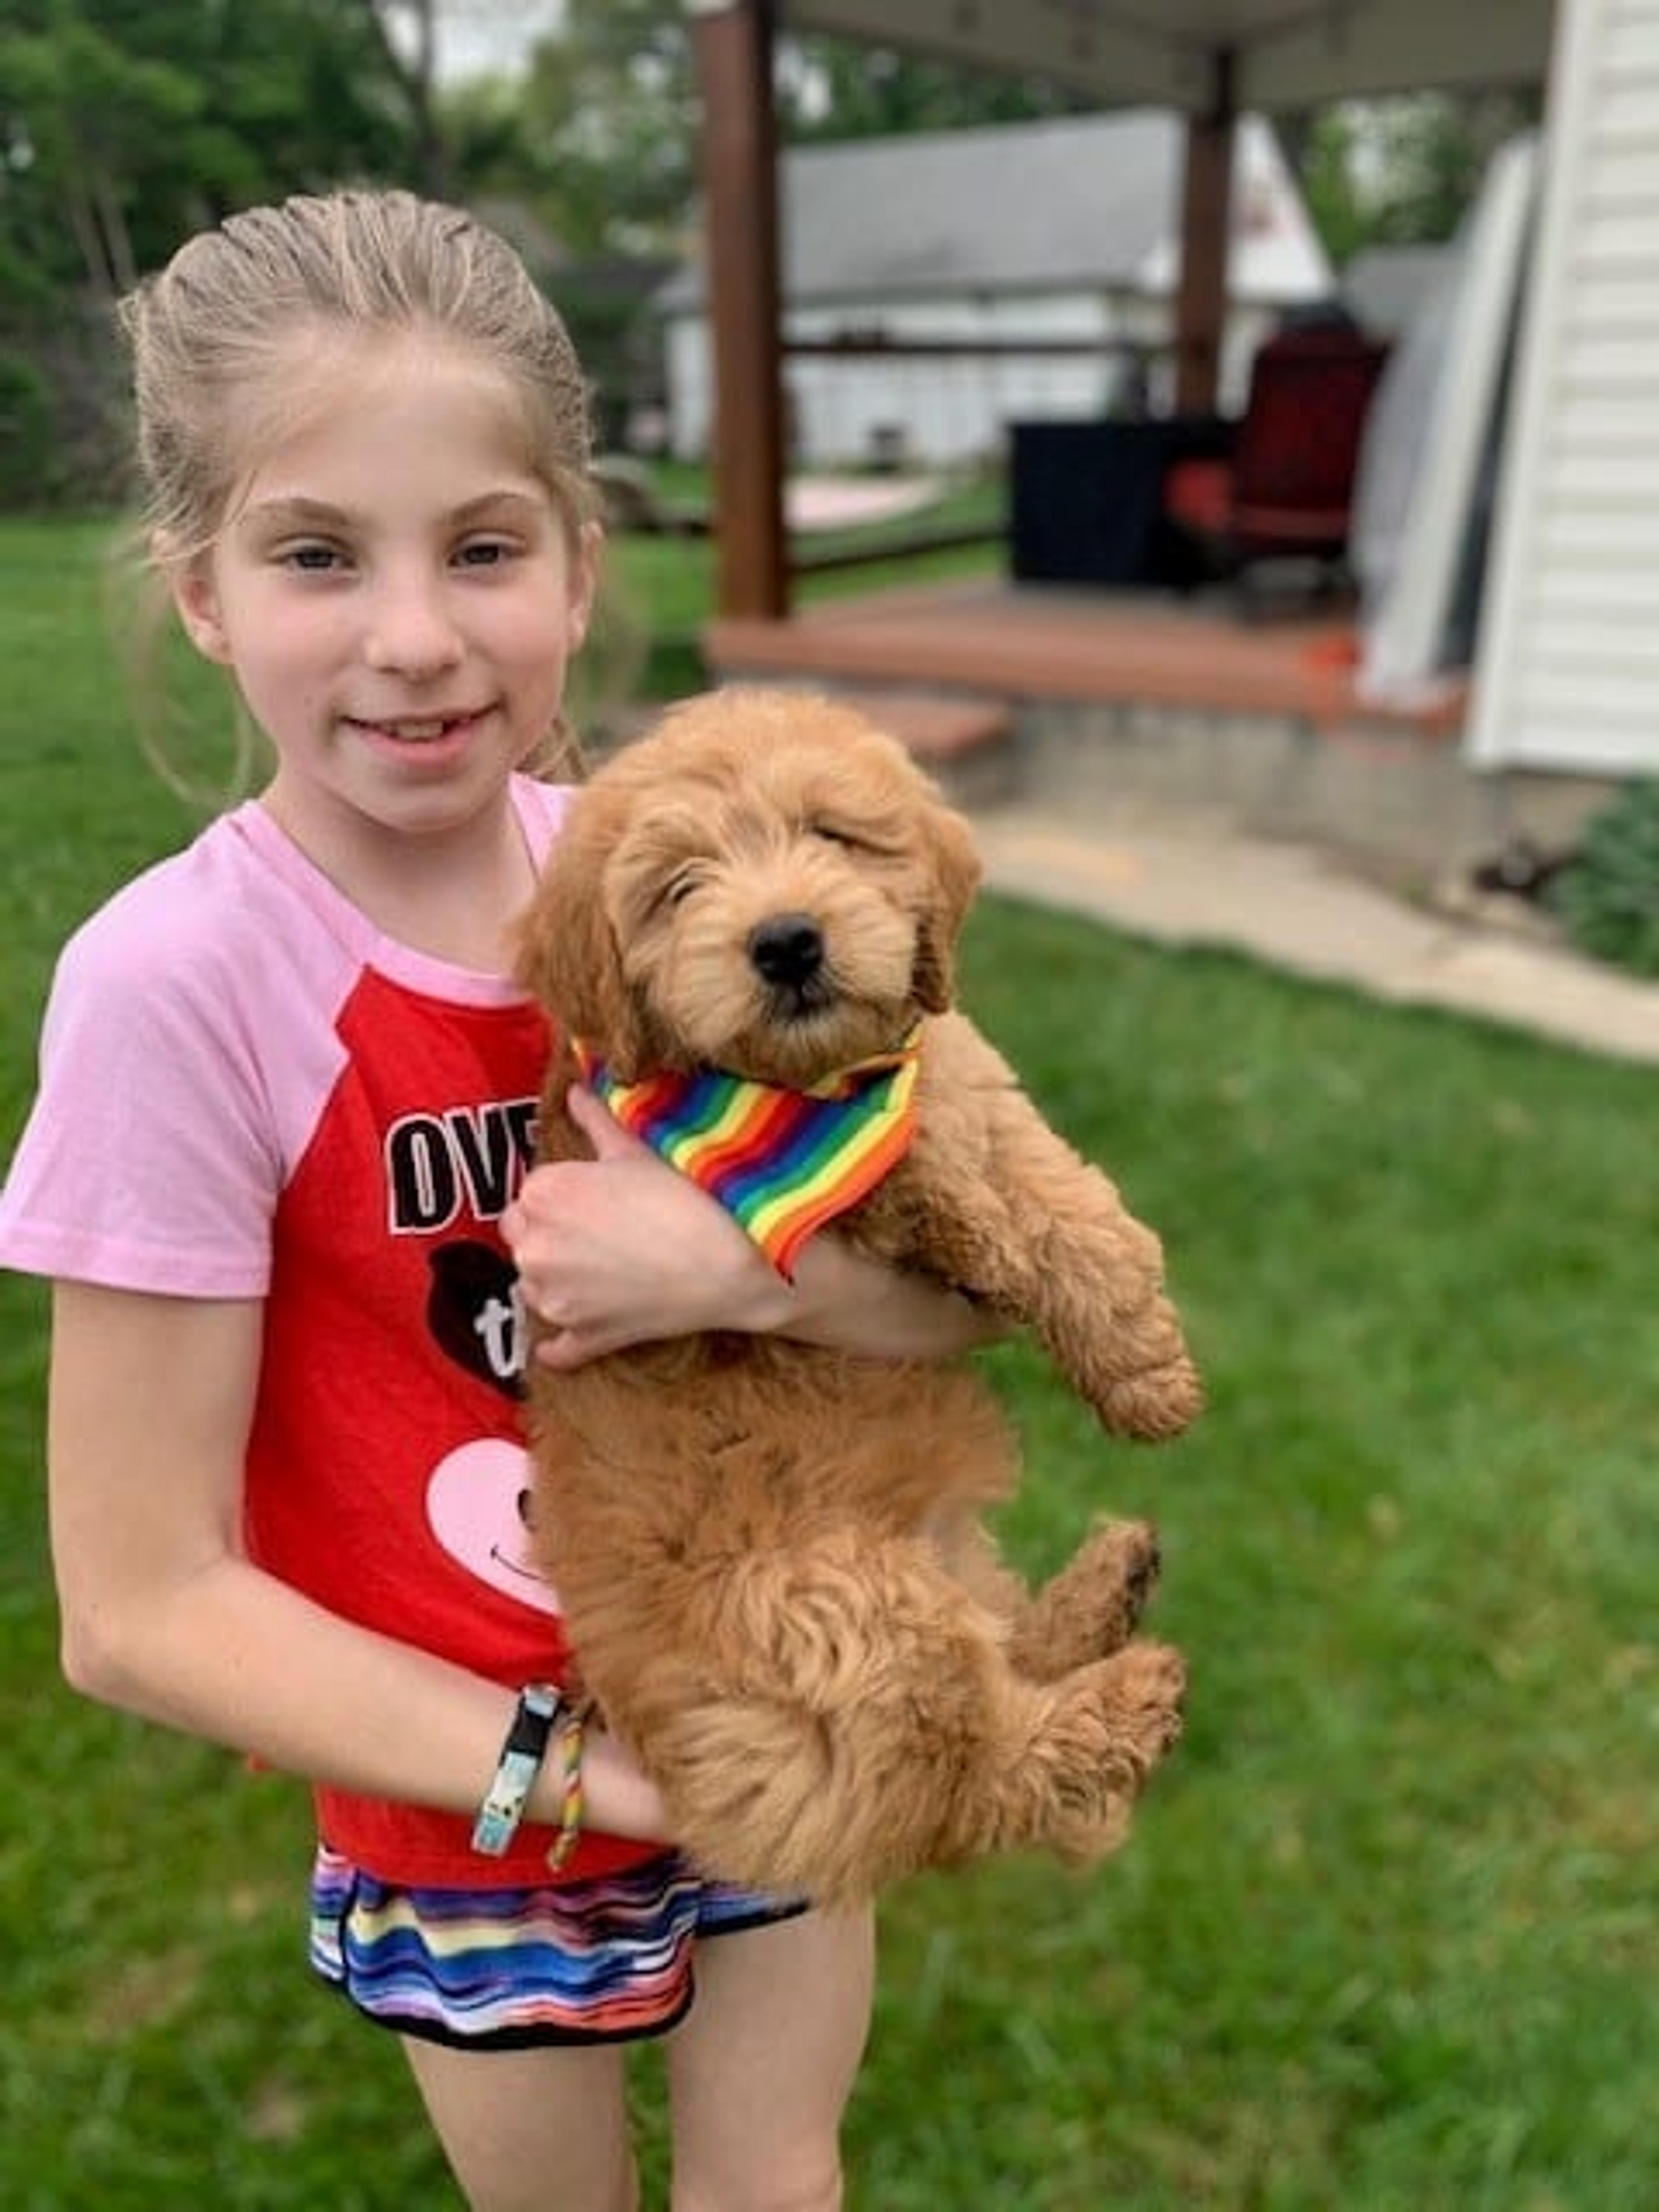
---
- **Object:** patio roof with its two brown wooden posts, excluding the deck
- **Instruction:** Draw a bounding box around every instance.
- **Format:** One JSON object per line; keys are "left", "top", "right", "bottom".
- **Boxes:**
{"left": 686, "top": 0, "right": 1553, "bottom": 617}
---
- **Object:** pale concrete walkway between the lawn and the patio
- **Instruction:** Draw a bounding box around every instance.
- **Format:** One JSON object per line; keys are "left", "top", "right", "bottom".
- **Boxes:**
{"left": 973, "top": 803, "right": 1659, "bottom": 1064}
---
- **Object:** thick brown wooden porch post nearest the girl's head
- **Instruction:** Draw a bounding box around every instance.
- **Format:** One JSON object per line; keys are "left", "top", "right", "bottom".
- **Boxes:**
{"left": 688, "top": 0, "right": 790, "bottom": 617}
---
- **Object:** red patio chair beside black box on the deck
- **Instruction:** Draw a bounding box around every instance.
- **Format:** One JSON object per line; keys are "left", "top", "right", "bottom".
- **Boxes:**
{"left": 1163, "top": 323, "right": 1387, "bottom": 601}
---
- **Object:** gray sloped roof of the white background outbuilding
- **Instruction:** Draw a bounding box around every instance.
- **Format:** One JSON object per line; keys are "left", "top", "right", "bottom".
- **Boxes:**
{"left": 659, "top": 108, "right": 1296, "bottom": 310}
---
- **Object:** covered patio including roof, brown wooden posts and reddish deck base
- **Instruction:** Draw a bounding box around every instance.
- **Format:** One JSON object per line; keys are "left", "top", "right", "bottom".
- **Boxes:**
{"left": 688, "top": 0, "right": 1575, "bottom": 867}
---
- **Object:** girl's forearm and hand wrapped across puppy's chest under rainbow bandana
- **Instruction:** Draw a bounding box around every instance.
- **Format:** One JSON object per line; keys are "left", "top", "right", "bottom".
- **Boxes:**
{"left": 502, "top": 1088, "right": 998, "bottom": 1367}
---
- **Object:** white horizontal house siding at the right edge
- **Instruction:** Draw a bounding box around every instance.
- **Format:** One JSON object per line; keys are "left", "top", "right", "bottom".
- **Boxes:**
{"left": 1469, "top": 0, "right": 1659, "bottom": 776}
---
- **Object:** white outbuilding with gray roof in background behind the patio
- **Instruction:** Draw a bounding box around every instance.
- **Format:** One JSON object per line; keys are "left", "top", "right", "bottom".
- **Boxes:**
{"left": 659, "top": 111, "right": 1332, "bottom": 467}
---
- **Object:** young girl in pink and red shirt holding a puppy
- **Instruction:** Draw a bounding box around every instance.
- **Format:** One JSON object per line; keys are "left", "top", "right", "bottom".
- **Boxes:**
{"left": 0, "top": 192, "right": 976, "bottom": 2212}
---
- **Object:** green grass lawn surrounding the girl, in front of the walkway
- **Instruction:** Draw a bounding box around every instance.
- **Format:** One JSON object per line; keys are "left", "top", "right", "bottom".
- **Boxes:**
{"left": 0, "top": 509, "right": 1659, "bottom": 2212}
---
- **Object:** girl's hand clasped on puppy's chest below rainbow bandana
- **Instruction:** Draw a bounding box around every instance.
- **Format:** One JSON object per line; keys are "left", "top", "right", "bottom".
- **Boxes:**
{"left": 502, "top": 1086, "right": 794, "bottom": 1367}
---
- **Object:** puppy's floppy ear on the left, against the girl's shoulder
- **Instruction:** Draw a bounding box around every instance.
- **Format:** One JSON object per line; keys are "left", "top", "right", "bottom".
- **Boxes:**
{"left": 513, "top": 785, "right": 635, "bottom": 1059}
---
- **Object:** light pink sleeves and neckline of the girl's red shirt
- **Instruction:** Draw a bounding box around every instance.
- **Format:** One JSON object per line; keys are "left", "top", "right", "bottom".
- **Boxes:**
{"left": 0, "top": 779, "right": 569, "bottom": 1298}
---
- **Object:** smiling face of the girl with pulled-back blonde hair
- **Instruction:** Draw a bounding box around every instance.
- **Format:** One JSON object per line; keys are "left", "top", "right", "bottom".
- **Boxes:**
{"left": 175, "top": 338, "right": 595, "bottom": 867}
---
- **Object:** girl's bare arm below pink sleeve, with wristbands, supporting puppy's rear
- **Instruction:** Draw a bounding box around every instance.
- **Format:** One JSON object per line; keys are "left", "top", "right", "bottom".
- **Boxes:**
{"left": 49, "top": 1283, "right": 661, "bottom": 1838}
